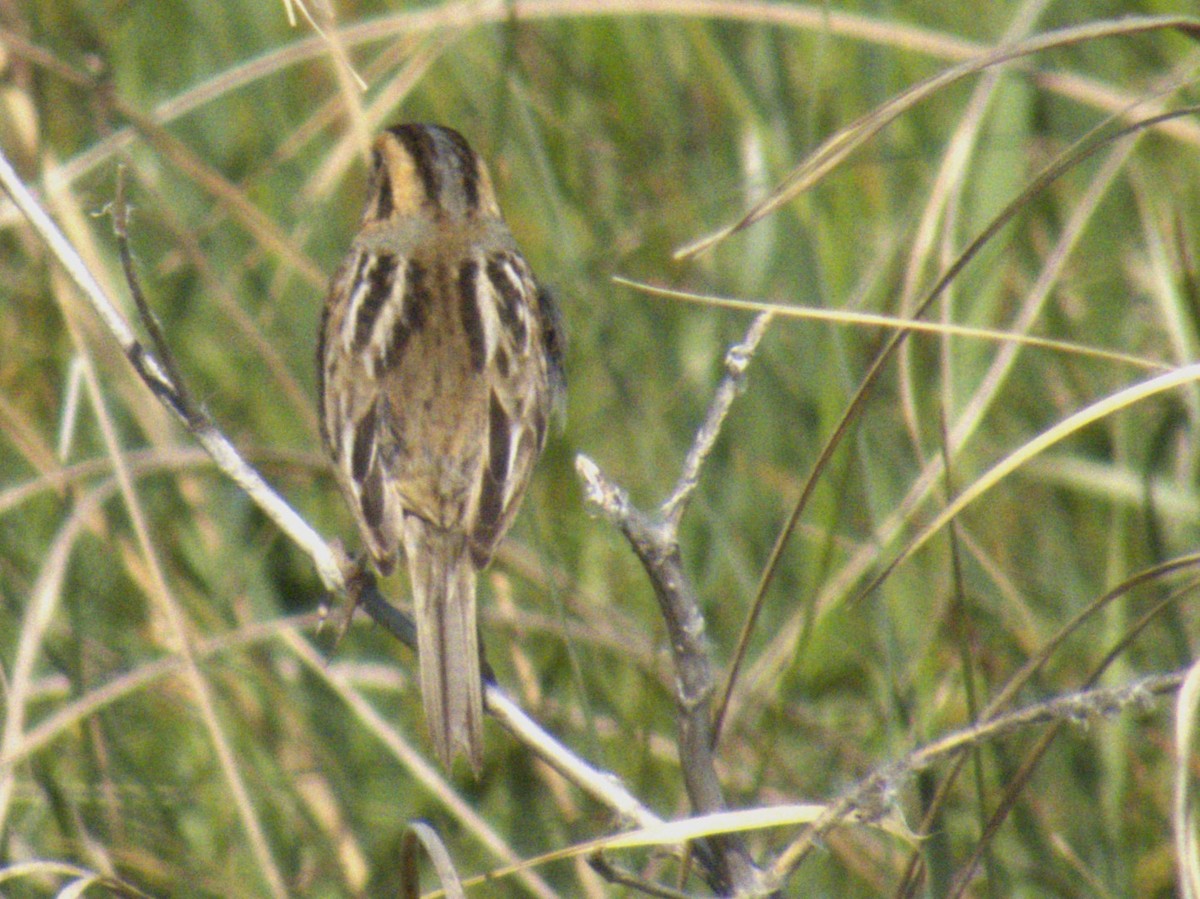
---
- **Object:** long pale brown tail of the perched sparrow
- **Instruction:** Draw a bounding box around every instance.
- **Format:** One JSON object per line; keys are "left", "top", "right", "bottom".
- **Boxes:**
{"left": 403, "top": 515, "right": 484, "bottom": 774}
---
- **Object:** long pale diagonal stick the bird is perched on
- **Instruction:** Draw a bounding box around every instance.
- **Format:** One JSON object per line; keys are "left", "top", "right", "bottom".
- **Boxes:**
{"left": 0, "top": 150, "right": 661, "bottom": 826}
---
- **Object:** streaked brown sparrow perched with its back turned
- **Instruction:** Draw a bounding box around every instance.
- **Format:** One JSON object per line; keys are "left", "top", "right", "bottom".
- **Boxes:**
{"left": 318, "top": 125, "right": 565, "bottom": 773}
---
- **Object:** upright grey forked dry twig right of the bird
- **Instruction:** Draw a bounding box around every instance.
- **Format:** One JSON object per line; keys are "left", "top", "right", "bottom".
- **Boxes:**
{"left": 575, "top": 313, "right": 770, "bottom": 894}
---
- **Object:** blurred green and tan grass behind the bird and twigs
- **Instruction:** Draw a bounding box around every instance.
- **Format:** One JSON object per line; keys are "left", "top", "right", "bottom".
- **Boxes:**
{"left": 0, "top": 0, "right": 1200, "bottom": 897}
